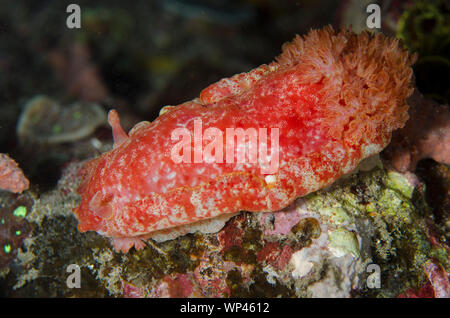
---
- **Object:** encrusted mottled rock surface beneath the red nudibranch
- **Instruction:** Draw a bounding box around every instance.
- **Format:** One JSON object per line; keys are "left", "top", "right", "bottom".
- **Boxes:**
{"left": 0, "top": 162, "right": 450, "bottom": 297}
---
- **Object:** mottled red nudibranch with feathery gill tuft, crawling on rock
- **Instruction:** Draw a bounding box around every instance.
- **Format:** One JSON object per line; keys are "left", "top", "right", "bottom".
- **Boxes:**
{"left": 74, "top": 26, "right": 416, "bottom": 252}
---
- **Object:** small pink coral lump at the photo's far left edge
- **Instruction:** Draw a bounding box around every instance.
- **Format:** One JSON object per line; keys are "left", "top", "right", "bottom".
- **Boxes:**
{"left": 0, "top": 153, "right": 30, "bottom": 193}
